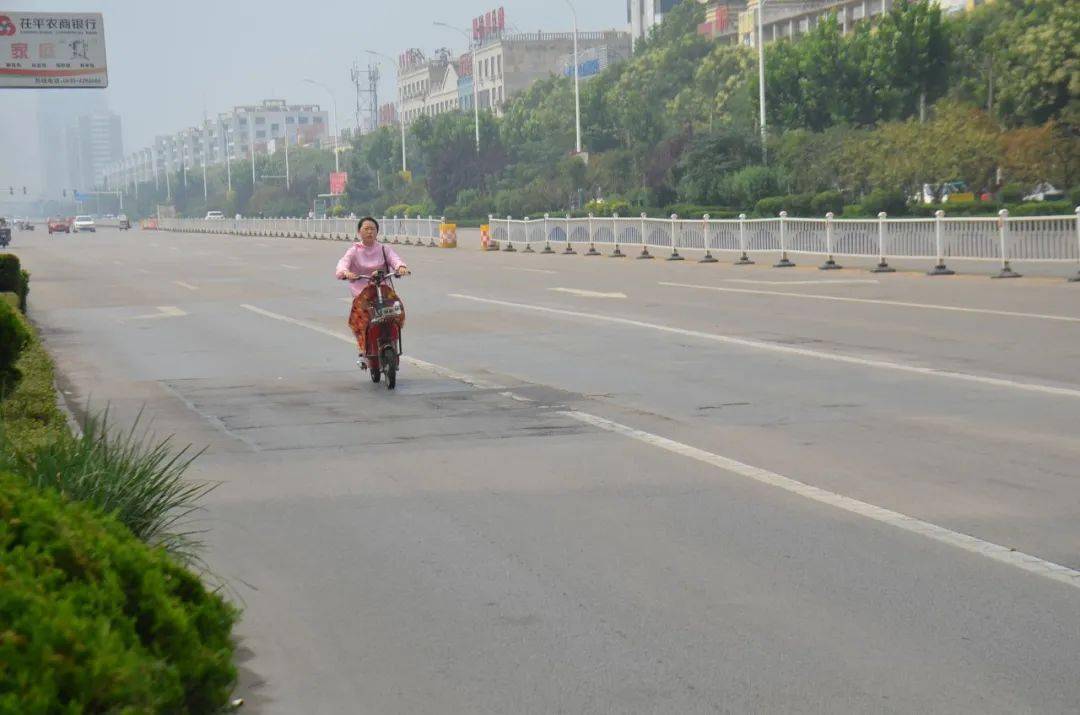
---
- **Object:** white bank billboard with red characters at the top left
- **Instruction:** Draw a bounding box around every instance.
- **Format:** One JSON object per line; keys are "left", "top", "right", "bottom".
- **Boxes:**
{"left": 0, "top": 10, "right": 109, "bottom": 89}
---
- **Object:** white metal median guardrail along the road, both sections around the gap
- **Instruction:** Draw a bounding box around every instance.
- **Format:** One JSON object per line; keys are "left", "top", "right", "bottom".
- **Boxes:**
{"left": 158, "top": 207, "right": 1080, "bottom": 276}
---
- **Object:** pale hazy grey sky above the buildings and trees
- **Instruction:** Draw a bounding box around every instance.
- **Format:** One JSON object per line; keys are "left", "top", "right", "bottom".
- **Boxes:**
{"left": 0, "top": 0, "right": 626, "bottom": 169}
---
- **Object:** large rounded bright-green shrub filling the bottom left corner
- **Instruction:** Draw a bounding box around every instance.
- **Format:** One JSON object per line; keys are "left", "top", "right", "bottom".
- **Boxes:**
{"left": 0, "top": 474, "right": 237, "bottom": 713}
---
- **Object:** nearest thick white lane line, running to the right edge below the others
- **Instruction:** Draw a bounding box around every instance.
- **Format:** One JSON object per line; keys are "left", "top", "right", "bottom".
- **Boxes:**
{"left": 559, "top": 410, "right": 1080, "bottom": 589}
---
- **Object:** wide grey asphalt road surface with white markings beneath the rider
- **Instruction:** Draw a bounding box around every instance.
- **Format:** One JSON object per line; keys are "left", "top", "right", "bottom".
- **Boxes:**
{"left": 13, "top": 230, "right": 1080, "bottom": 713}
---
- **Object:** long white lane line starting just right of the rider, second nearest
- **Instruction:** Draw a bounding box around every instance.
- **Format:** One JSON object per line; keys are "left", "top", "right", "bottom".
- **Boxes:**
{"left": 449, "top": 293, "right": 1080, "bottom": 399}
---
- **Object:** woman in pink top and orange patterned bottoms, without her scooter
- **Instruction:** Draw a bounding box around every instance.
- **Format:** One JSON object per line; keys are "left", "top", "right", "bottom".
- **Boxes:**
{"left": 336, "top": 216, "right": 411, "bottom": 369}
